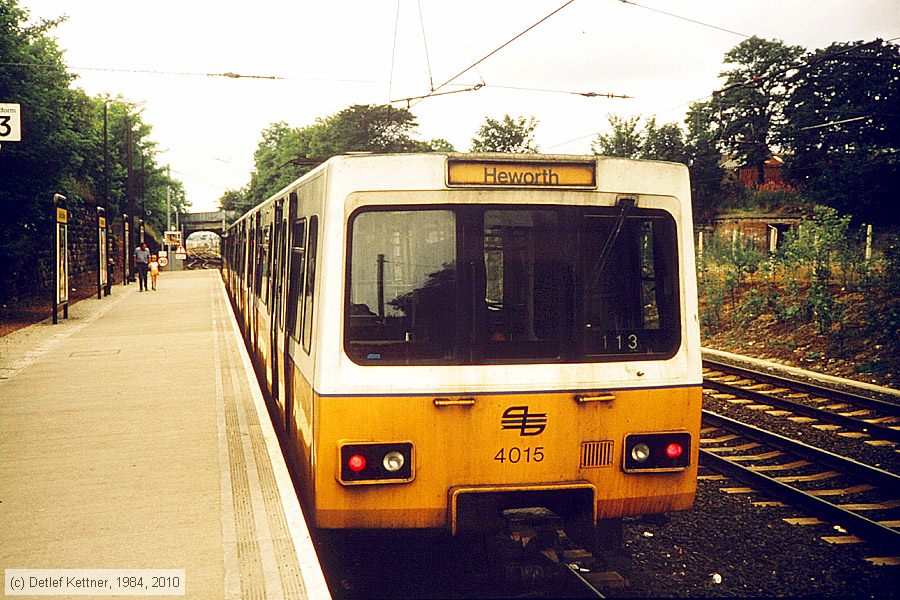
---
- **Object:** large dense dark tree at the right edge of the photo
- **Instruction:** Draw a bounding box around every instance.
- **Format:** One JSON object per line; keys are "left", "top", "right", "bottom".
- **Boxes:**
{"left": 781, "top": 40, "right": 900, "bottom": 224}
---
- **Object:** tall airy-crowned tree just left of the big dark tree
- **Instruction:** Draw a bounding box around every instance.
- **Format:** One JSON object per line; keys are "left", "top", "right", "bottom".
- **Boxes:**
{"left": 713, "top": 36, "right": 804, "bottom": 183}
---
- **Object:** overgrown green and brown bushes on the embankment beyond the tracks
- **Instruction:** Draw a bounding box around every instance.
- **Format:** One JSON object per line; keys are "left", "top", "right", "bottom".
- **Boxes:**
{"left": 697, "top": 206, "right": 900, "bottom": 377}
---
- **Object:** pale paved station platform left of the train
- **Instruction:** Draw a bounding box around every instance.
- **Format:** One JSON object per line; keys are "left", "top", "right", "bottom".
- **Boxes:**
{"left": 0, "top": 271, "right": 330, "bottom": 599}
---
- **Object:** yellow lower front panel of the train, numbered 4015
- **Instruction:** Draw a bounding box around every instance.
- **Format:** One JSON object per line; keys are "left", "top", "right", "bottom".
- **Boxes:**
{"left": 314, "top": 387, "right": 701, "bottom": 529}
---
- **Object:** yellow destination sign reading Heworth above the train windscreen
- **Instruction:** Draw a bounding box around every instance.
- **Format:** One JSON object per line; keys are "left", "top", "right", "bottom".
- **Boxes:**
{"left": 447, "top": 159, "right": 596, "bottom": 188}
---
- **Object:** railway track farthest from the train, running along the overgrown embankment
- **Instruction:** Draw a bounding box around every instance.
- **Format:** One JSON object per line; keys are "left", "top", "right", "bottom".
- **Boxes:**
{"left": 703, "top": 359, "right": 900, "bottom": 445}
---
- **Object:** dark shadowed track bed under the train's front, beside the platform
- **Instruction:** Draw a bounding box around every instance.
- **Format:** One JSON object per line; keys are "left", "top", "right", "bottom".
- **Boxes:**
{"left": 317, "top": 524, "right": 627, "bottom": 600}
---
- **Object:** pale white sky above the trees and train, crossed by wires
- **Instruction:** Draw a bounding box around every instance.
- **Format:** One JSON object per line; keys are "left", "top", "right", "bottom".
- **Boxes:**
{"left": 17, "top": 0, "right": 900, "bottom": 211}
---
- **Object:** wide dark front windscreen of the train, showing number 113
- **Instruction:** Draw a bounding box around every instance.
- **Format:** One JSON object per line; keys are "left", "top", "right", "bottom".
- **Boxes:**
{"left": 344, "top": 205, "right": 681, "bottom": 364}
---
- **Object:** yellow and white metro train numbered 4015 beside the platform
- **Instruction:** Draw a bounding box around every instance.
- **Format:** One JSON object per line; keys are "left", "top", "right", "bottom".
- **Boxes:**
{"left": 222, "top": 153, "right": 702, "bottom": 543}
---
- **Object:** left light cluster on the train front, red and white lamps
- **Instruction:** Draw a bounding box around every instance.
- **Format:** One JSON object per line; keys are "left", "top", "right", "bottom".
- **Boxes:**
{"left": 336, "top": 442, "right": 414, "bottom": 485}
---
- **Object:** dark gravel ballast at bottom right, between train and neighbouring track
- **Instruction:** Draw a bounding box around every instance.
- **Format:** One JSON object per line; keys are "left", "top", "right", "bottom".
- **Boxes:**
{"left": 606, "top": 481, "right": 900, "bottom": 598}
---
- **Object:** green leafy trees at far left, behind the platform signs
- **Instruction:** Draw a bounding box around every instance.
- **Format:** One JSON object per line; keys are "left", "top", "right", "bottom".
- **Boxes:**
{"left": 0, "top": 0, "right": 184, "bottom": 303}
